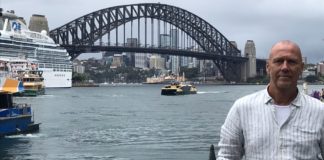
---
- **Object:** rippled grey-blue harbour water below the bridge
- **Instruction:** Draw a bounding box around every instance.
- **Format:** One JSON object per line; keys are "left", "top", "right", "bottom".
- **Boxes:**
{"left": 0, "top": 85, "right": 324, "bottom": 160}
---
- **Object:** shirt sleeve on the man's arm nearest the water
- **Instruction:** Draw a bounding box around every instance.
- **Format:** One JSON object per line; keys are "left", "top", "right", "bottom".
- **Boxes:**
{"left": 217, "top": 102, "right": 244, "bottom": 160}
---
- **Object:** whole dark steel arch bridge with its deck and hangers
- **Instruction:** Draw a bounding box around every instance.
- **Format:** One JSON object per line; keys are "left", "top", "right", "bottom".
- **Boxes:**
{"left": 49, "top": 3, "right": 247, "bottom": 81}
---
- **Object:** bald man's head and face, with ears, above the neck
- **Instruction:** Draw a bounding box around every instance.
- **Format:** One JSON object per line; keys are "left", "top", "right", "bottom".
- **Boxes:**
{"left": 267, "top": 43, "right": 304, "bottom": 90}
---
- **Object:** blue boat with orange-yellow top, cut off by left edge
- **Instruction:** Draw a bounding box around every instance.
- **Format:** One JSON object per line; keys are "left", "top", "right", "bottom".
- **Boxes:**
{"left": 0, "top": 71, "right": 40, "bottom": 137}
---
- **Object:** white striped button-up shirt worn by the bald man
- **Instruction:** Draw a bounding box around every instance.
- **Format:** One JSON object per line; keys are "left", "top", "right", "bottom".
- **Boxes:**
{"left": 217, "top": 89, "right": 324, "bottom": 160}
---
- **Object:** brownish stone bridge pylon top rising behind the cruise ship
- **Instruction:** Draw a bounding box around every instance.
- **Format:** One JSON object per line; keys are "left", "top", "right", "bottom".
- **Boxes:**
{"left": 28, "top": 14, "right": 49, "bottom": 34}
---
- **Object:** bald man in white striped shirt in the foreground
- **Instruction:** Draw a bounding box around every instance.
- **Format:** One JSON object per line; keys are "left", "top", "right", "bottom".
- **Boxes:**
{"left": 217, "top": 40, "right": 324, "bottom": 160}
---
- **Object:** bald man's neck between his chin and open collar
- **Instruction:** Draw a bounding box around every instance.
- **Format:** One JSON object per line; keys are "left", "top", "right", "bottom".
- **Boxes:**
{"left": 267, "top": 85, "right": 298, "bottom": 105}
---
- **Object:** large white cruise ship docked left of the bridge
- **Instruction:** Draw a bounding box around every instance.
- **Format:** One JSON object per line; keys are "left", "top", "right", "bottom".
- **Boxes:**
{"left": 0, "top": 10, "right": 72, "bottom": 88}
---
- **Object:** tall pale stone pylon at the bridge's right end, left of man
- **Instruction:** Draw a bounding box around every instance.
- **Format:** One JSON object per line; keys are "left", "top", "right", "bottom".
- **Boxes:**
{"left": 244, "top": 40, "right": 256, "bottom": 78}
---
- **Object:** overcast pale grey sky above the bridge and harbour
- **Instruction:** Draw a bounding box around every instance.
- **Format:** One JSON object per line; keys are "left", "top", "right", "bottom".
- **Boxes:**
{"left": 0, "top": 0, "right": 324, "bottom": 63}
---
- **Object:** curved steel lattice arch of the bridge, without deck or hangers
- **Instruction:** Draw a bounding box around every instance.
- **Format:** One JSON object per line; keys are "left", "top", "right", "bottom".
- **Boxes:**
{"left": 50, "top": 3, "right": 245, "bottom": 81}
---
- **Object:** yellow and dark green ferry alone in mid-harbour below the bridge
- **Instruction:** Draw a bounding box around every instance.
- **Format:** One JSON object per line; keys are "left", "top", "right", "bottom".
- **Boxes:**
{"left": 161, "top": 82, "right": 197, "bottom": 96}
